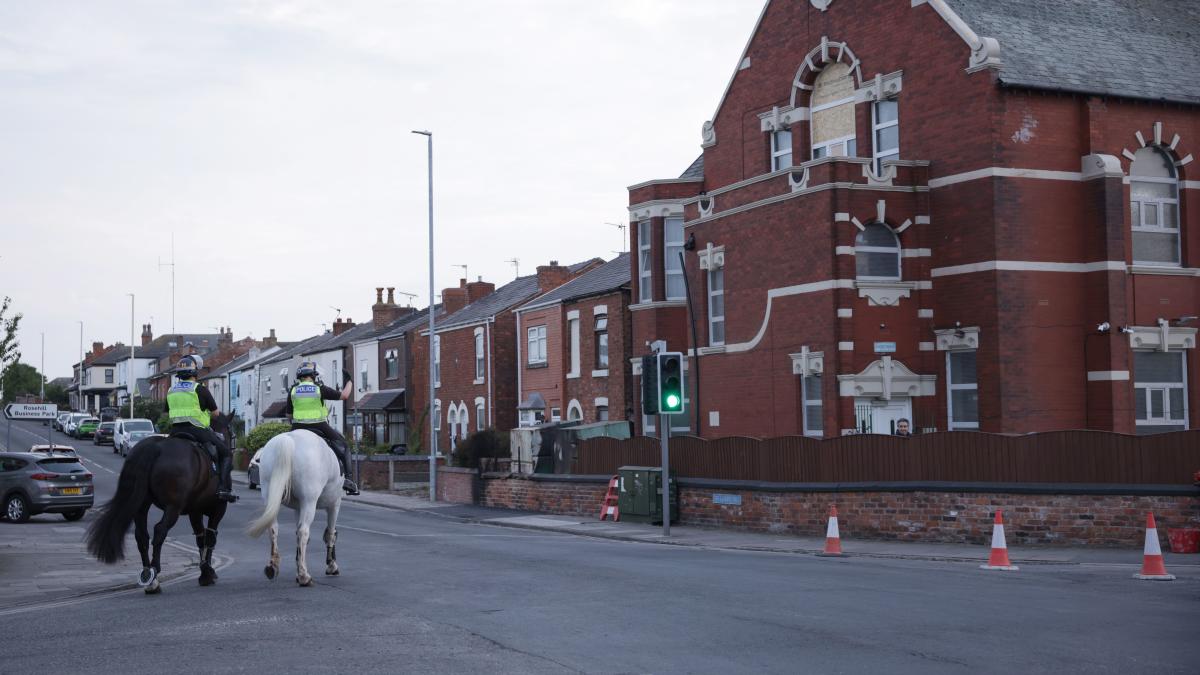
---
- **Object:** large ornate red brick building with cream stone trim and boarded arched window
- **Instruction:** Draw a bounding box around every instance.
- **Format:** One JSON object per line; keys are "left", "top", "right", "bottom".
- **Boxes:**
{"left": 629, "top": 0, "right": 1200, "bottom": 436}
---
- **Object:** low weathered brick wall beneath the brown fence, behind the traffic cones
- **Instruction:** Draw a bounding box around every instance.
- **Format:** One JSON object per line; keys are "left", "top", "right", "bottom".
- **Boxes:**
{"left": 463, "top": 474, "right": 1200, "bottom": 548}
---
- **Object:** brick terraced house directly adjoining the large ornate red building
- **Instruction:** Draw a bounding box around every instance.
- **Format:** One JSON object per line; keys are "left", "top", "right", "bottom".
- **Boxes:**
{"left": 516, "top": 253, "right": 632, "bottom": 426}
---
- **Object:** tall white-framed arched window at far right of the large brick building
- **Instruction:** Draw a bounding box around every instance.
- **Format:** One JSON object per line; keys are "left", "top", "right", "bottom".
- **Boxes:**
{"left": 1129, "top": 147, "right": 1181, "bottom": 265}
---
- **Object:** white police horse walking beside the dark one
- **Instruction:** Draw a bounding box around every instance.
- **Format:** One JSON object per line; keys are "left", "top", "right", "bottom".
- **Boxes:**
{"left": 247, "top": 431, "right": 342, "bottom": 586}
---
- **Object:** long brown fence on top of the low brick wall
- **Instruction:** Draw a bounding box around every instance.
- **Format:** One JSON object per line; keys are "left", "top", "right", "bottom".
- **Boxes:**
{"left": 574, "top": 430, "right": 1200, "bottom": 485}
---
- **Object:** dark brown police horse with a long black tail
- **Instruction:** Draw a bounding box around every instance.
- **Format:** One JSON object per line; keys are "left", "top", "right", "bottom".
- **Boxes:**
{"left": 86, "top": 416, "right": 229, "bottom": 593}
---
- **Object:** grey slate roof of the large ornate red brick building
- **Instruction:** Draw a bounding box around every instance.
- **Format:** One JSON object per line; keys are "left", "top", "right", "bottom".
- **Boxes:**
{"left": 947, "top": 0, "right": 1200, "bottom": 103}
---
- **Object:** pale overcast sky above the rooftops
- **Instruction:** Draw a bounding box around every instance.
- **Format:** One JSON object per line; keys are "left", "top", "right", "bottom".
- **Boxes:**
{"left": 0, "top": 0, "right": 762, "bottom": 377}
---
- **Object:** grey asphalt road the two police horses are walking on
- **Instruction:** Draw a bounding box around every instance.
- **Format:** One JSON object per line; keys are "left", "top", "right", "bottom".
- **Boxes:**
{"left": 0, "top": 417, "right": 1200, "bottom": 674}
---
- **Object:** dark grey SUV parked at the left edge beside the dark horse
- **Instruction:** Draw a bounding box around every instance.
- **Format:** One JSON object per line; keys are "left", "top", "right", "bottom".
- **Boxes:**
{"left": 0, "top": 453, "right": 96, "bottom": 522}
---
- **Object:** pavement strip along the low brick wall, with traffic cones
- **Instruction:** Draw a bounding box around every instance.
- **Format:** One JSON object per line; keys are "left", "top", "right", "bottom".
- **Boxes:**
{"left": 241, "top": 472, "right": 1200, "bottom": 566}
